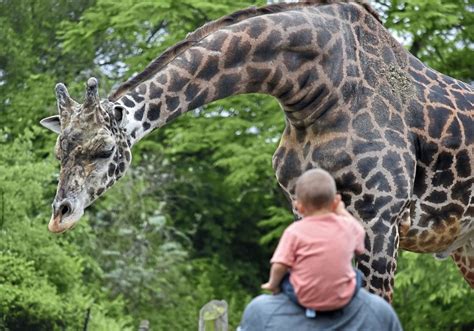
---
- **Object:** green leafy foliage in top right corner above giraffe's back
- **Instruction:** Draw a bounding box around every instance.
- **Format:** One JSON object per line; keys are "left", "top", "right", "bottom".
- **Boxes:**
{"left": 382, "top": 0, "right": 474, "bottom": 82}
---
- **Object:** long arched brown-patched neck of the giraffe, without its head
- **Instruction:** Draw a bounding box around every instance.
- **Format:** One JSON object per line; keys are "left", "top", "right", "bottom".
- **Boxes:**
{"left": 118, "top": 4, "right": 396, "bottom": 143}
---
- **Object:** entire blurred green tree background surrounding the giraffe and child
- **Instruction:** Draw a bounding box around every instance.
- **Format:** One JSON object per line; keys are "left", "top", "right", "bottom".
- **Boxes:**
{"left": 0, "top": 0, "right": 474, "bottom": 330}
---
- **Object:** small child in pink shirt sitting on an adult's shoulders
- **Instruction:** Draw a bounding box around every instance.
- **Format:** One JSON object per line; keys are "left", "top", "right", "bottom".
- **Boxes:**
{"left": 262, "top": 169, "right": 365, "bottom": 317}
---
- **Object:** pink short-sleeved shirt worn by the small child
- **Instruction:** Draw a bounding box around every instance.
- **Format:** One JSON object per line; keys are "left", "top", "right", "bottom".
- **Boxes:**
{"left": 271, "top": 213, "right": 365, "bottom": 310}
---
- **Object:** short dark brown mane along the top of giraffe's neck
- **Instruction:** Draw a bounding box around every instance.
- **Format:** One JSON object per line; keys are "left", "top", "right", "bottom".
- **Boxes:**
{"left": 108, "top": 0, "right": 382, "bottom": 102}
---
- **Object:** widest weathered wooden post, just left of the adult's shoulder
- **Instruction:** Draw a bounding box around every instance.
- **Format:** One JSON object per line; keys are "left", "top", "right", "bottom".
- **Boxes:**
{"left": 199, "top": 300, "right": 229, "bottom": 331}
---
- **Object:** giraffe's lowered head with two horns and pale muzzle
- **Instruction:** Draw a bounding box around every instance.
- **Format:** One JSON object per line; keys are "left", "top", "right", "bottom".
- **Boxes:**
{"left": 41, "top": 78, "right": 131, "bottom": 233}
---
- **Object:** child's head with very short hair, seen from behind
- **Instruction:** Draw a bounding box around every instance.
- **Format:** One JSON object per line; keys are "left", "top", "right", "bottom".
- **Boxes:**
{"left": 295, "top": 169, "right": 340, "bottom": 216}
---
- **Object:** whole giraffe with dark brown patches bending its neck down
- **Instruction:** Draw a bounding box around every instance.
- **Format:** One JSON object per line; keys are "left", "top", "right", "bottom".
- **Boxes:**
{"left": 41, "top": 0, "right": 474, "bottom": 301}
